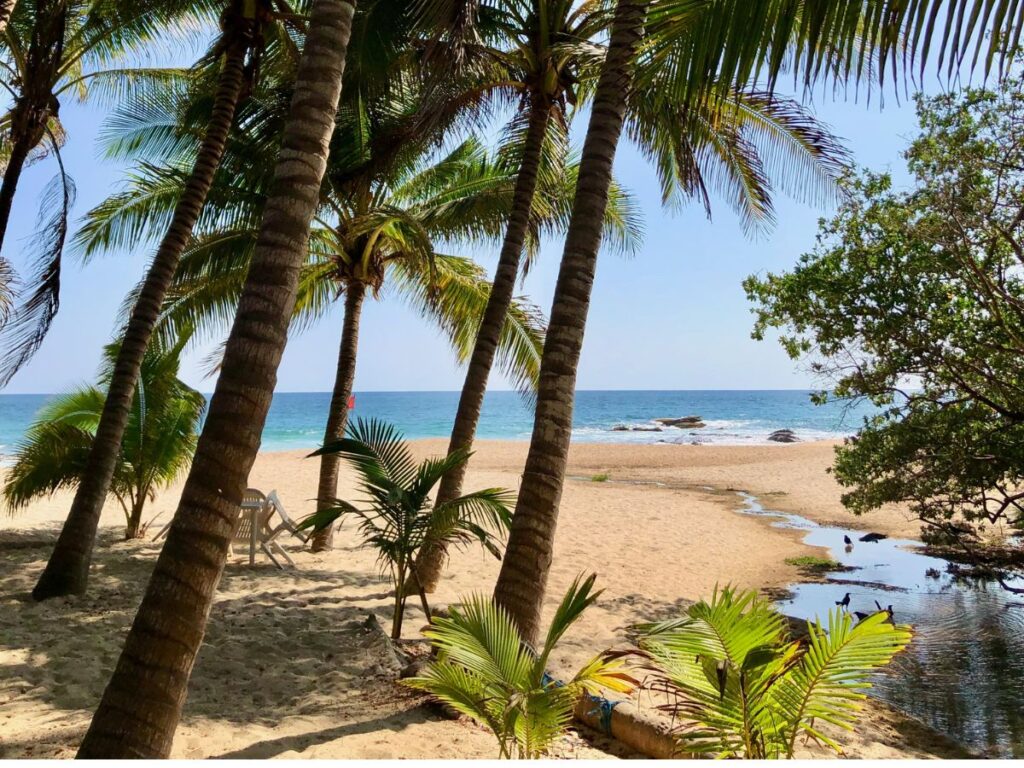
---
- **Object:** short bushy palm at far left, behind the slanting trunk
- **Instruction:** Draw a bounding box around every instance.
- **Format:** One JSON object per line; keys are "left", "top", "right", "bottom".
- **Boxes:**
{"left": 3, "top": 341, "right": 206, "bottom": 539}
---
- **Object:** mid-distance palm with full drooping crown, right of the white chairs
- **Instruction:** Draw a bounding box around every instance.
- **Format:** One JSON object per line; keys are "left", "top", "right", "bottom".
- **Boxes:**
{"left": 156, "top": 139, "right": 552, "bottom": 551}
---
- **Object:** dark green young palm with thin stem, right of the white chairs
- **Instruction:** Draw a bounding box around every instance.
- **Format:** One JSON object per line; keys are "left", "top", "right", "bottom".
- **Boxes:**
{"left": 299, "top": 419, "right": 512, "bottom": 640}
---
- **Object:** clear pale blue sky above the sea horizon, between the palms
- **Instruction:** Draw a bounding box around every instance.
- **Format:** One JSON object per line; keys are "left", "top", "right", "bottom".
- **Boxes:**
{"left": 5, "top": 57, "right": 929, "bottom": 393}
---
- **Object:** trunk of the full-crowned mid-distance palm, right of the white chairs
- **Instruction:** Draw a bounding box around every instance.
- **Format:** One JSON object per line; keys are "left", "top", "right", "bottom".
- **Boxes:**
{"left": 310, "top": 281, "right": 367, "bottom": 552}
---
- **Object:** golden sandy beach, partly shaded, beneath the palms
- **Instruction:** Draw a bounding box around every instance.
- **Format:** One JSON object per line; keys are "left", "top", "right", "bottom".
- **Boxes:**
{"left": 0, "top": 440, "right": 959, "bottom": 758}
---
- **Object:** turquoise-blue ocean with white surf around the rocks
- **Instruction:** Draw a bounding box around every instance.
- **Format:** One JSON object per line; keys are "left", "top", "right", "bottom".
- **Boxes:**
{"left": 0, "top": 389, "right": 871, "bottom": 456}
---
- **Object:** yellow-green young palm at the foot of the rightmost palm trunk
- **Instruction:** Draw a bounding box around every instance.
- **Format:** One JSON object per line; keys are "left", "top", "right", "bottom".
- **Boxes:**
{"left": 406, "top": 574, "right": 636, "bottom": 758}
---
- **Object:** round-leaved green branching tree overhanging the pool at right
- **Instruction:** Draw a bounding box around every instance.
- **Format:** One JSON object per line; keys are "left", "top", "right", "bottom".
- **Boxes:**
{"left": 745, "top": 77, "right": 1024, "bottom": 581}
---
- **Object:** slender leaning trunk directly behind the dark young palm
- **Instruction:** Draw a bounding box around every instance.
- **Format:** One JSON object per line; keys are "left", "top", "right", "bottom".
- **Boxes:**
{"left": 416, "top": 96, "right": 551, "bottom": 593}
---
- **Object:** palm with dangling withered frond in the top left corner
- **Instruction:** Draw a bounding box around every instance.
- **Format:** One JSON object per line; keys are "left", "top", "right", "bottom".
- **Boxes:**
{"left": 0, "top": 0, "right": 207, "bottom": 391}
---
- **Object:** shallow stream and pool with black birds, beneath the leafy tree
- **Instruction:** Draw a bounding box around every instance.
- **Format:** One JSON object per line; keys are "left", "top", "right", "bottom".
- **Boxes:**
{"left": 741, "top": 494, "right": 1024, "bottom": 758}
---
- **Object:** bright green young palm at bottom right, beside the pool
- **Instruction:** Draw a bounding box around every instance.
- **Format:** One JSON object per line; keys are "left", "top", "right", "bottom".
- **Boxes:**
{"left": 637, "top": 587, "right": 911, "bottom": 760}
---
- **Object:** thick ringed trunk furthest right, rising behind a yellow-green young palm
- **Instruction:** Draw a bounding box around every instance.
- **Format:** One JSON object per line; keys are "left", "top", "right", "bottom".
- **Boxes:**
{"left": 495, "top": 0, "right": 649, "bottom": 642}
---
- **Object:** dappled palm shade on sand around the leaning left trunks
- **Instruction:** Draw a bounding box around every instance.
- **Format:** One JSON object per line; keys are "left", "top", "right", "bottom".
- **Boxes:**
{"left": 0, "top": 529, "right": 419, "bottom": 743}
